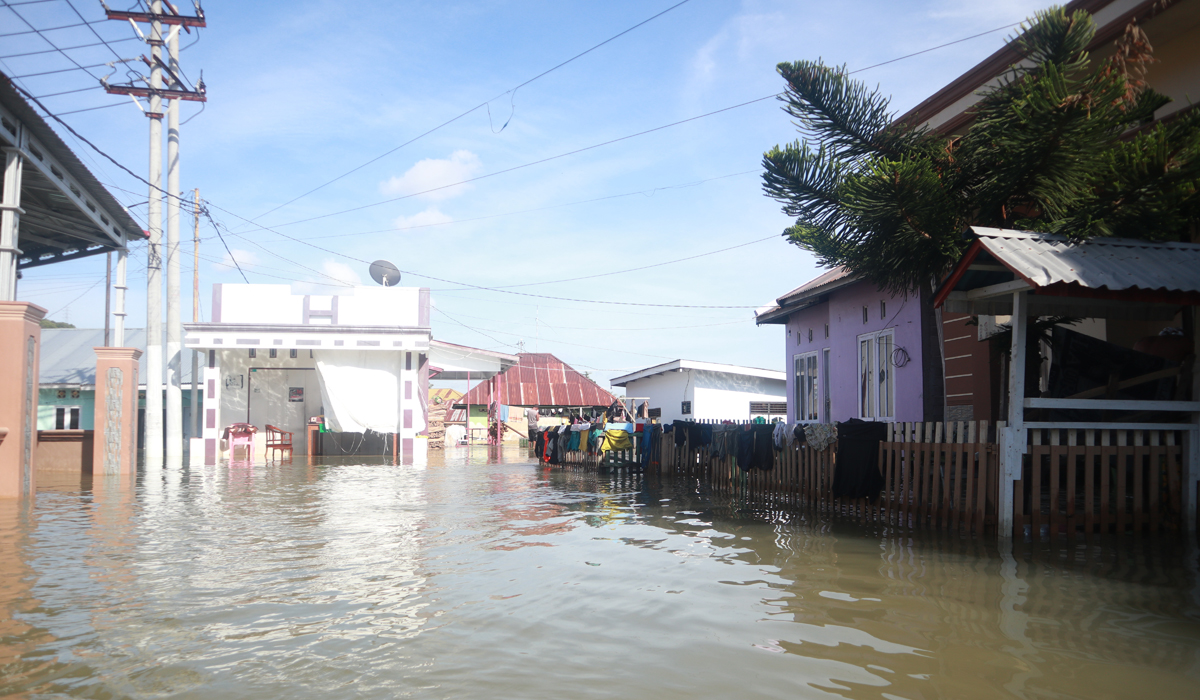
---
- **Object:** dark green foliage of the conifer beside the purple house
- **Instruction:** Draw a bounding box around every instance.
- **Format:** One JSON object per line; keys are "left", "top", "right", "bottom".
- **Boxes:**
{"left": 763, "top": 7, "right": 1200, "bottom": 294}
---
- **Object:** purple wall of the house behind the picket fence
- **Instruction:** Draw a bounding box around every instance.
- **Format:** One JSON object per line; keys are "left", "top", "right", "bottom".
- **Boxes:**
{"left": 784, "top": 282, "right": 924, "bottom": 423}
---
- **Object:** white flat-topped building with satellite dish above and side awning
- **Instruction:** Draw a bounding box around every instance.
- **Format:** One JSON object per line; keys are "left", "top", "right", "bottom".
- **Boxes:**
{"left": 184, "top": 285, "right": 517, "bottom": 463}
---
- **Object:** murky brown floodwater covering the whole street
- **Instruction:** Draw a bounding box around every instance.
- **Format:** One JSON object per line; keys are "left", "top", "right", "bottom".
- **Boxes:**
{"left": 0, "top": 448, "right": 1200, "bottom": 700}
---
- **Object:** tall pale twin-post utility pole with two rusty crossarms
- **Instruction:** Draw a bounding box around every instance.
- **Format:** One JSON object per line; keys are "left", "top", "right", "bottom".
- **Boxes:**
{"left": 101, "top": 0, "right": 206, "bottom": 467}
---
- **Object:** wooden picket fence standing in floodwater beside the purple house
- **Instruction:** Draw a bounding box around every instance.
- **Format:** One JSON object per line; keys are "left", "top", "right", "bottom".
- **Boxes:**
{"left": 542, "top": 420, "right": 1184, "bottom": 539}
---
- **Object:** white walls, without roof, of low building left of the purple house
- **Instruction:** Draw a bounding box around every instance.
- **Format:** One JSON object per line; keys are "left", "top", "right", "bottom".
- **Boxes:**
{"left": 625, "top": 369, "right": 787, "bottom": 423}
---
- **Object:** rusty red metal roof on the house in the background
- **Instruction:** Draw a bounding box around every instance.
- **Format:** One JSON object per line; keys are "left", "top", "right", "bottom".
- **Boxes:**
{"left": 455, "top": 353, "right": 617, "bottom": 406}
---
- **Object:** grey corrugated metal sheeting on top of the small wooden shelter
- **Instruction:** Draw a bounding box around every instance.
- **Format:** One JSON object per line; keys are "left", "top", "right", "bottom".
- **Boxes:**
{"left": 972, "top": 227, "right": 1200, "bottom": 292}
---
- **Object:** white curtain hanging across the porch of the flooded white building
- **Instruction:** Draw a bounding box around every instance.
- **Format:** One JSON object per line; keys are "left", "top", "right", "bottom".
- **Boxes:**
{"left": 313, "top": 351, "right": 403, "bottom": 432}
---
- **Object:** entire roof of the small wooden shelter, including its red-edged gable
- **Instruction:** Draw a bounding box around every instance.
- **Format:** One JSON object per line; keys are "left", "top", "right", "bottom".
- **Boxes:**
{"left": 934, "top": 226, "right": 1200, "bottom": 318}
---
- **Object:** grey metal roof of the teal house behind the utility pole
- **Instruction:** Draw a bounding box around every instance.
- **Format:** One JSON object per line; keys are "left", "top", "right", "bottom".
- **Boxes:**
{"left": 37, "top": 328, "right": 192, "bottom": 387}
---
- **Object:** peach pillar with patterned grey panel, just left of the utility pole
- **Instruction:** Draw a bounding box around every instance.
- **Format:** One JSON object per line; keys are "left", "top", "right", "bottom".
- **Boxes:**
{"left": 91, "top": 347, "right": 142, "bottom": 474}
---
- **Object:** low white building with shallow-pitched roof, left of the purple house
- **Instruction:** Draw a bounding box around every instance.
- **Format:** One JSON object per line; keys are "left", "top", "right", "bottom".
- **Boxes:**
{"left": 610, "top": 360, "right": 787, "bottom": 423}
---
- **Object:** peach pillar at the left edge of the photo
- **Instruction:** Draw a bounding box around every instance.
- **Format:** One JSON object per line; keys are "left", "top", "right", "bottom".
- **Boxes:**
{"left": 0, "top": 301, "right": 46, "bottom": 498}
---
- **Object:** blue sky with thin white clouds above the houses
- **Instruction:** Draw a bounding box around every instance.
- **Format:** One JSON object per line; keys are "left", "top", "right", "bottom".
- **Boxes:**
{"left": 0, "top": 0, "right": 1046, "bottom": 387}
